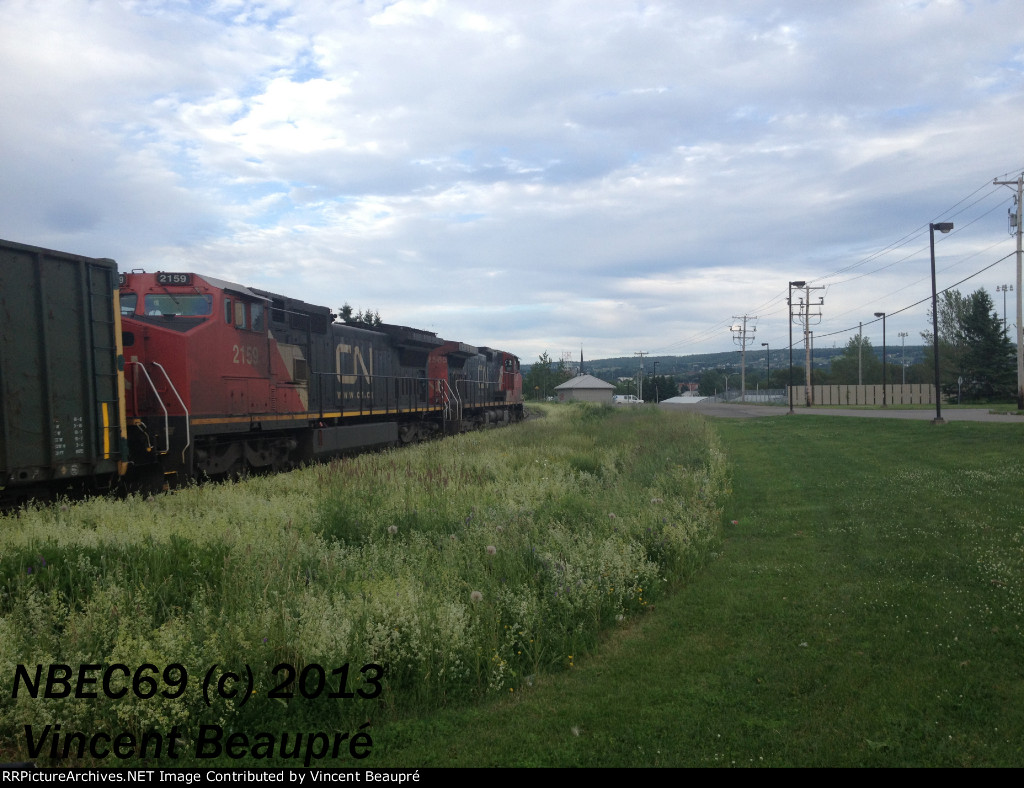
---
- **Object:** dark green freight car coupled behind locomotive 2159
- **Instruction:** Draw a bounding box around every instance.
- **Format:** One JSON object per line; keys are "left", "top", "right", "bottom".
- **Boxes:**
{"left": 0, "top": 240, "right": 126, "bottom": 506}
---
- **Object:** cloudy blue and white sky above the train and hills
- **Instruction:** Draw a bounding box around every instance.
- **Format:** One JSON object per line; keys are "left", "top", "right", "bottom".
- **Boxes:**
{"left": 0, "top": 0, "right": 1024, "bottom": 362}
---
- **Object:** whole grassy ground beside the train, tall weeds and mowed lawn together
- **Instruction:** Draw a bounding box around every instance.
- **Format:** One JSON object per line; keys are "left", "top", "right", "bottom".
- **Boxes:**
{"left": 0, "top": 407, "right": 1024, "bottom": 768}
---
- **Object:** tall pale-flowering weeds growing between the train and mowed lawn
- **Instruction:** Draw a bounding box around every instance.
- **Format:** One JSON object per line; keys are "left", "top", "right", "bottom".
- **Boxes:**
{"left": 0, "top": 406, "right": 727, "bottom": 757}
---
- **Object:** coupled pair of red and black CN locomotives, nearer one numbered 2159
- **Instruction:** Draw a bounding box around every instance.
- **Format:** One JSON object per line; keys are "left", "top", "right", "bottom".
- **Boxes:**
{"left": 120, "top": 273, "right": 522, "bottom": 485}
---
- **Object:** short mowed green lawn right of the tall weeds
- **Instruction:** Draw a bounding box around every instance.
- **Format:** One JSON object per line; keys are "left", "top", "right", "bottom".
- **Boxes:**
{"left": 374, "top": 415, "right": 1024, "bottom": 767}
